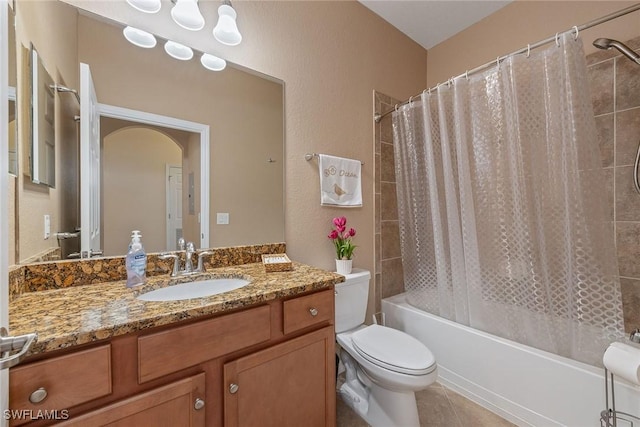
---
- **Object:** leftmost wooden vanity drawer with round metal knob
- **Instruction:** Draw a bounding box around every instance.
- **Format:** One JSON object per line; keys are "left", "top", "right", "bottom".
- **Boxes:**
{"left": 9, "top": 344, "right": 111, "bottom": 425}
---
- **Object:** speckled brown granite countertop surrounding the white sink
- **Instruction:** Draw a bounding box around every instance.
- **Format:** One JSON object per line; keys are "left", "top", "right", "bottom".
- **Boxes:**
{"left": 9, "top": 262, "right": 344, "bottom": 354}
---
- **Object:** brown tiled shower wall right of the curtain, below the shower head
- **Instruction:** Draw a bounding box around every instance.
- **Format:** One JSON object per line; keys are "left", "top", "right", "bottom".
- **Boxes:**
{"left": 587, "top": 37, "right": 640, "bottom": 331}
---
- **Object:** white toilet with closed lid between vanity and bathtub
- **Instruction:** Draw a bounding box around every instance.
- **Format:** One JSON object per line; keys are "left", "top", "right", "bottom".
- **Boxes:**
{"left": 335, "top": 269, "right": 437, "bottom": 427}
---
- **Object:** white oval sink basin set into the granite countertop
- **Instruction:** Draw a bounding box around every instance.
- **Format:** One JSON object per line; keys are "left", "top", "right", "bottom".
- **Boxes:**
{"left": 138, "top": 279, "right": 249, "bottom": 301}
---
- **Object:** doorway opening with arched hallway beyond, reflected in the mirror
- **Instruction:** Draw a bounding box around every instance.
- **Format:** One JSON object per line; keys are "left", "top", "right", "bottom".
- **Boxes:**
{"left": 100, "top": 117, "right": 200, "bottom": 256}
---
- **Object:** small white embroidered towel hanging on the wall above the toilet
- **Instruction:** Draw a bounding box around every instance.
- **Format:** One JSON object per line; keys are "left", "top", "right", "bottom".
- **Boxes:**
{"left": 318, "top": 154, "right": 362, "bottom": 208}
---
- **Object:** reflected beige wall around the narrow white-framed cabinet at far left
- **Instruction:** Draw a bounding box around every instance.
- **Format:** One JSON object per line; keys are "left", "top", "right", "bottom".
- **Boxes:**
{"left": 9, "top": 2, "right": 78, "bottom": 261}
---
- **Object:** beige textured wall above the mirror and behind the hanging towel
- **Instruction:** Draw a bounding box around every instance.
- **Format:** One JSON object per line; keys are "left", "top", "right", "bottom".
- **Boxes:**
{"left": 67, "top": 1, "right": 426, "bottom": 284}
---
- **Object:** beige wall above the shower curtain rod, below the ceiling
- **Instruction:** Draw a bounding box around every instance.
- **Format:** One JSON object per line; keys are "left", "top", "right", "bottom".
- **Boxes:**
{"left": 424, "top": 0, "right": 640, "bottom": 88}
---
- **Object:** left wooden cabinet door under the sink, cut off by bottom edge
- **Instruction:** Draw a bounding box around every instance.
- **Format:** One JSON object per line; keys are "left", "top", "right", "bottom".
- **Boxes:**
{"left": 59, "top": 373, "right": 205, "bottom": 427}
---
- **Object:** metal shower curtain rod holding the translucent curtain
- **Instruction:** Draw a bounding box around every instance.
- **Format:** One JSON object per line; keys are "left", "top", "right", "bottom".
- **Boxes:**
{"left": 373, "top": 3, "right": 640, "bottom": 123}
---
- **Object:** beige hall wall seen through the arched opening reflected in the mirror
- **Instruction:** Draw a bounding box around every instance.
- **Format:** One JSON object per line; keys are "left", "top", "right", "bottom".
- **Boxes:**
{"left": 101, "top": 127, "right": 182, "bottom": 256}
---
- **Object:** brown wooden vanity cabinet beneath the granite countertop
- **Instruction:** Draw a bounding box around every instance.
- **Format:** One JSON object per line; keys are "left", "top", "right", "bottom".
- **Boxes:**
{"left": 9, "top": 288, "right": 335, "bottom": 427}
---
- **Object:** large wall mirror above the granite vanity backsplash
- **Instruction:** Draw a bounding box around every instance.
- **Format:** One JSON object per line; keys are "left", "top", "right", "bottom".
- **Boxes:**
{"left": 10, "top": 1, "right": 284, "bottom": 263}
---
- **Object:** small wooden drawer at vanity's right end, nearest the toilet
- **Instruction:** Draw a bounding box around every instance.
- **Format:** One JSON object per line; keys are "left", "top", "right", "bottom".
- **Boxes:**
{"left": 283, "top": 289, "right": 334, "bottom": 334}
